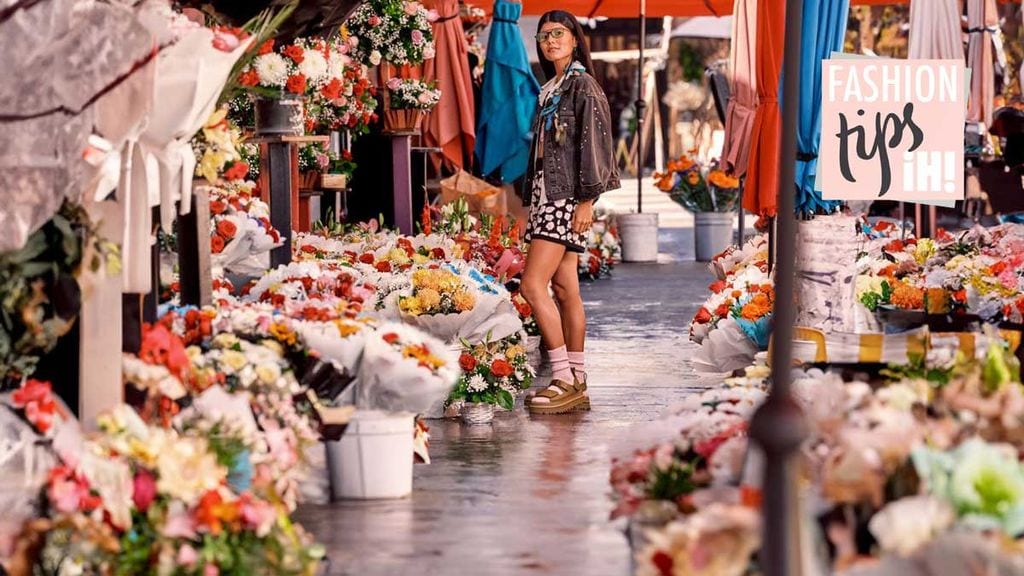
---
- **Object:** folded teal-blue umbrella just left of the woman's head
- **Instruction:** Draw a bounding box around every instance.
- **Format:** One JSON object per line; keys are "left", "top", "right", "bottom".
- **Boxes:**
{"left": 476, "top": 0, "right": 541, "bottom": 182}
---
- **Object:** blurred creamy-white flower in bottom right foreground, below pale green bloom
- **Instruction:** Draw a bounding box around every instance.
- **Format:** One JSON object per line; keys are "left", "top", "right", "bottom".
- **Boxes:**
{"left": 867, "top": 496, "right": 954, "bottom": 556}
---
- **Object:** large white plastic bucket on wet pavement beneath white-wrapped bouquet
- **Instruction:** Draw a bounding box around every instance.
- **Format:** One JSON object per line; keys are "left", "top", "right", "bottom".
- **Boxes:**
{"left": 326, "top": 410, "right": 416, "bottom": 500}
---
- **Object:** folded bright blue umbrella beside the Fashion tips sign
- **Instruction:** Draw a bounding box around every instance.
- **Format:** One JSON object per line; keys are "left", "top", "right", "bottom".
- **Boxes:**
{"left": 796, "top": 0, "right": 850, "bottom": 214}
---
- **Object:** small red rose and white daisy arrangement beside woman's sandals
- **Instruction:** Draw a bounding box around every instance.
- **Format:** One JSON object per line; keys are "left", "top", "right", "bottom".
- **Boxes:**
{"left": 446, "top": 334, "right": 534, "bottom": 410}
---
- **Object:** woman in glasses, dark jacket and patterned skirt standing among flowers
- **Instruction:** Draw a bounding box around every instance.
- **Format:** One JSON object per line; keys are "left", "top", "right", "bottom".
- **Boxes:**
{"left": 521, "top": 10, "right": 620, "bottom": 414}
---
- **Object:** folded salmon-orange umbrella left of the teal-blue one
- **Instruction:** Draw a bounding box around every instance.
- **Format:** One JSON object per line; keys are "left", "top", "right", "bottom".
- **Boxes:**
{"left": 423, "top": 0, "right": 476, "bottom": 168}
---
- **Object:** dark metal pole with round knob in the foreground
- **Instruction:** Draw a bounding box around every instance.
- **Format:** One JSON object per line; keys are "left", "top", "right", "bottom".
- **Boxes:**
{"left": 751, "top": 0, "right": 808, "bottom": 576}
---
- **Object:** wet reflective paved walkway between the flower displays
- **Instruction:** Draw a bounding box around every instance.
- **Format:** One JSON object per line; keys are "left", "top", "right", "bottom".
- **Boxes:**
{"left": 298, "top": 229, "right": 712, "bottom": 575}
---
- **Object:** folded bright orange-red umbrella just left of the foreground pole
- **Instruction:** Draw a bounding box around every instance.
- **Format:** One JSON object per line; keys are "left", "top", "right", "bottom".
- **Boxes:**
{"left": 743, "top": 2, "right": 785, "bottom": 216}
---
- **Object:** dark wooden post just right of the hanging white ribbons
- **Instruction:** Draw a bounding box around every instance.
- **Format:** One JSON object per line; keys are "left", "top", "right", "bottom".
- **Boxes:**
{"left": 178, "top": 186, "right": 213, "bottom": 307}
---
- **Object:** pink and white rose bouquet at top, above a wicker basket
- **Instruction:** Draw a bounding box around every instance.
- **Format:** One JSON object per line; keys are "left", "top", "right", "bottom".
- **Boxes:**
{"left": 343, "top": 0, "right": 437, "bottom": 66}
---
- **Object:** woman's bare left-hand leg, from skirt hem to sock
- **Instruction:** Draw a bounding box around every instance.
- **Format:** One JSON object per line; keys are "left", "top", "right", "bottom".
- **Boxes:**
{"left": 520, "top": 240, "right": 579, "bottom": 349}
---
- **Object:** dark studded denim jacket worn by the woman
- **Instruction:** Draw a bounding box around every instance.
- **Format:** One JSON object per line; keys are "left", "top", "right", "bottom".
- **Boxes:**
{"left": 522, "top": 69, "right": 622, "bottom": 205}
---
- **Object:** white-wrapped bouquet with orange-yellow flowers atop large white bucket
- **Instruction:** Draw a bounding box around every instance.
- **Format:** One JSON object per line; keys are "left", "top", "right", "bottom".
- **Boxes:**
{"left": 355, "top": 323, "right": 459, "bottom": 413}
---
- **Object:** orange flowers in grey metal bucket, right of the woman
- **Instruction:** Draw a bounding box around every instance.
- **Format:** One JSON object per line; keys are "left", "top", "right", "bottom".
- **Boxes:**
{"left": 654, "top": 155, "right": 740, "bottom": 262}
